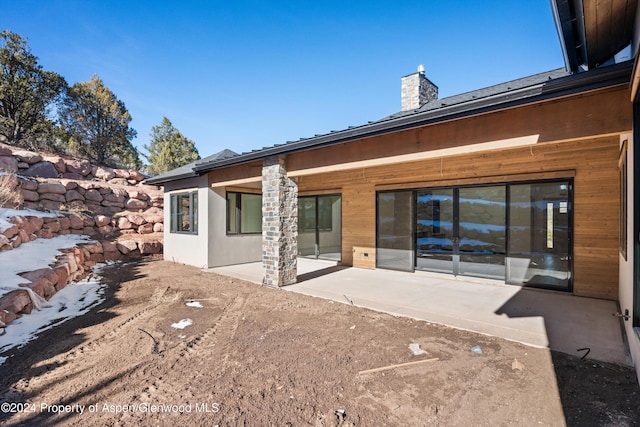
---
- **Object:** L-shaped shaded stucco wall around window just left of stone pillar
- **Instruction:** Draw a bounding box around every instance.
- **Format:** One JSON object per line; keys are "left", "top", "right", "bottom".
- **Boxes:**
{"left": 208, "top": 188, "right": 262, "bottom": 267}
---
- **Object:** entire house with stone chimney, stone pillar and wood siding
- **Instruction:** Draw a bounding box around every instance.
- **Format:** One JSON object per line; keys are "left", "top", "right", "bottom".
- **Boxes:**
{"left": 147, "top": 0, "right": 640, "bottom": 382}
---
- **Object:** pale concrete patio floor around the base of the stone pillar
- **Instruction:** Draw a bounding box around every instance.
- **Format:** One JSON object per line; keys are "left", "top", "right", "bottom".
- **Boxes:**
{"left": 208, "top": 258, "right": 631, "bottom": 365}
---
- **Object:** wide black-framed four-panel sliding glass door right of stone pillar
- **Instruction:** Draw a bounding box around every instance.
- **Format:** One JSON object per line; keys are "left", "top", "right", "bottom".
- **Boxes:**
{"left": 376, "top": 180, "right": 572, "bottom": 290}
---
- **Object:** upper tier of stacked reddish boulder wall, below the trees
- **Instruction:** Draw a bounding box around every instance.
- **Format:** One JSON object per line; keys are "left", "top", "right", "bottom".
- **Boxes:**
{"left": 0, "top": 144, "right": 164, "bottom": 254}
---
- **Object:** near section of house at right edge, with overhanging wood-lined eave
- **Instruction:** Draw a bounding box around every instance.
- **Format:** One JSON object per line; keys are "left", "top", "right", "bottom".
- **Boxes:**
{"left": 551, "top": 0, "right": 640, "bottom": 379}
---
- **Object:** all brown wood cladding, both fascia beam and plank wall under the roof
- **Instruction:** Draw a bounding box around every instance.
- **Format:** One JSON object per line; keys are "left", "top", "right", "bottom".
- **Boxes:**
{"left": 209, "top": 85, "right": 632, "bottom": 300}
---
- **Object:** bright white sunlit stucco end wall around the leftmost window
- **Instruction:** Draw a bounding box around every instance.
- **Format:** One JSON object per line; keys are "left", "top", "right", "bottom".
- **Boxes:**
{"left": 164, "top": 176, "right": 209, "bottom": 268}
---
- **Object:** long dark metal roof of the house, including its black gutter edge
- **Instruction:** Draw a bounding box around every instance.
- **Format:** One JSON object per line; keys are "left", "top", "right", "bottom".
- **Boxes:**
{"left": 147, "top": 61, "right": 633, "bottom": 183}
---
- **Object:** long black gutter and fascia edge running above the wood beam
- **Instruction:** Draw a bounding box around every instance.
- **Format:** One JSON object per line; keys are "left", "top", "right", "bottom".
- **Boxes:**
{"left": 194, "top": 61, "right": 633, "bottom": 174}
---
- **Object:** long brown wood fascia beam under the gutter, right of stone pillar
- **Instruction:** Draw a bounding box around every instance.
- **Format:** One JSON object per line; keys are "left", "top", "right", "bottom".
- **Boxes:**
{"left": 287, "top": 86, "right": 632, "bottom": 173}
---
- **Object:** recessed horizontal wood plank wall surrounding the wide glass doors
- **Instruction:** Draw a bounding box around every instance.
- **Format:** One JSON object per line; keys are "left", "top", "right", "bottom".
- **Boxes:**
{"left": 298, "top": 137, "right": 619, "bottom": 299}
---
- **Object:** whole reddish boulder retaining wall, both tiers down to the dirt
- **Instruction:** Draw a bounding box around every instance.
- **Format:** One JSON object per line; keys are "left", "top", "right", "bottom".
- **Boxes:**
{"left": 0, "top": 144, "right": 164, "bottom": 335}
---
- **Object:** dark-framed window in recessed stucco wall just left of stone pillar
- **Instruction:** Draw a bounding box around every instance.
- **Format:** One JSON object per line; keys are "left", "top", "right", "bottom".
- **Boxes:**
{"left": 227, "top": 192, "right": 262, "bottom": 234}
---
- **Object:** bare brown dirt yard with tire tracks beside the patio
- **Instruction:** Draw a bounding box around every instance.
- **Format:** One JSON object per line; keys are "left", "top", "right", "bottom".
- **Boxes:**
{"left": 0, "top": 260, "right": 640, "bottom": 426}
